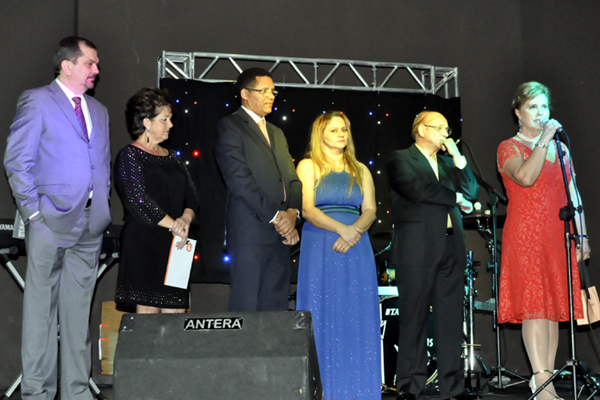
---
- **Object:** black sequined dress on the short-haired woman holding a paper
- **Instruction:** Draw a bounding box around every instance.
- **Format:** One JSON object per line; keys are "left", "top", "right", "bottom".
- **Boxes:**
{"left": 114, "top": 145, "right": 198, "bottom": 308}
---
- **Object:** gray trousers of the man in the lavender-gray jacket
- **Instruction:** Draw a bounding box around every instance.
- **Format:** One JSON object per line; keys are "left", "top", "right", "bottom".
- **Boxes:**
{"left": 21, "top": 209, "right": 102, "bottom": 400}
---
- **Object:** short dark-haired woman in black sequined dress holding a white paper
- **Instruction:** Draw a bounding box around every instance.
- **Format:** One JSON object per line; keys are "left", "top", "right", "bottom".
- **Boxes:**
{"left": 114, "top": 88, "right": 198, "bottom": 314}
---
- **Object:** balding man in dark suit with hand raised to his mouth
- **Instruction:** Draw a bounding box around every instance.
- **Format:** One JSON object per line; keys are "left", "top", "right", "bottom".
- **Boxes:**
{"left": 387, "top": 111, "right": 479, "bottom": 399}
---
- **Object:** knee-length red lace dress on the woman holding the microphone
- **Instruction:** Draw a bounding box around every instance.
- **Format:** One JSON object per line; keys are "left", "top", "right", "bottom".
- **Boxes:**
{"left": 498, "top": 138, "right": 583, "bottom": 323}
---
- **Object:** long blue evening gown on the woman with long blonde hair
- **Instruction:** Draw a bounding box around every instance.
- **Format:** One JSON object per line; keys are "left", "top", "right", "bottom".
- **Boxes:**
{"left": 296, "top": 172, "right": 381, "bottom": 400}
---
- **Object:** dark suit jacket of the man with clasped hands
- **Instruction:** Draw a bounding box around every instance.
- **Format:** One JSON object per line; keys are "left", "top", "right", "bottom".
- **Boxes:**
{"left": 215, "top": 108, "right": 302, "bottom": 246}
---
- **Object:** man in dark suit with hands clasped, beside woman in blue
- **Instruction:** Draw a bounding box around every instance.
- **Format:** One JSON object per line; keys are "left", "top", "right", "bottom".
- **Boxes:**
{"left": 215, "top": 68, "right": 302, "bottom": 311}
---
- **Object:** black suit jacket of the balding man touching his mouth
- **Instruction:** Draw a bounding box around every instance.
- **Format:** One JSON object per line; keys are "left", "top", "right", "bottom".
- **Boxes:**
{"left": 387, "top": 144, "right": 479, "bottom": 265}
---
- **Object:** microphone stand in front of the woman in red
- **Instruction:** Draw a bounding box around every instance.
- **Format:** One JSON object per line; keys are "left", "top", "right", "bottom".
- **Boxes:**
{"left": 529, "top": 132, "right": 598, "bottom": 400}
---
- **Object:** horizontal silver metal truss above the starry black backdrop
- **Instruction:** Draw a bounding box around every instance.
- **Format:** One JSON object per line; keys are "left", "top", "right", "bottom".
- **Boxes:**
{"left": 158, "top": 51, "right": 458, "bottom": 98}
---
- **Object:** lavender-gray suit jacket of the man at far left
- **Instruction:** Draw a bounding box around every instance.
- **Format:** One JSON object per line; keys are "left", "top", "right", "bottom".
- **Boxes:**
{"left": 4, "top": 81, "right": 111, "bottom": 236}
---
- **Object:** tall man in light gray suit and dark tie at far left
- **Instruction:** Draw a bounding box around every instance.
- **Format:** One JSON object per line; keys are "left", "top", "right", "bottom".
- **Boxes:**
{"left": 4, "top": 36, "right": 111, "bottom": 400}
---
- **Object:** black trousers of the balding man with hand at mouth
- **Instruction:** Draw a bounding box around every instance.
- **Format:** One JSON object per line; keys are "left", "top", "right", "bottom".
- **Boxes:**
{"left": 395, "top": 235, "right": 466, "bottom": 399}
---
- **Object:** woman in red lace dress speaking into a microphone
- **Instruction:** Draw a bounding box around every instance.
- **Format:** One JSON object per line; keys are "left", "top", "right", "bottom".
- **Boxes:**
{"left": 498, "top": 82, "right": 590, "bottom": 400}
